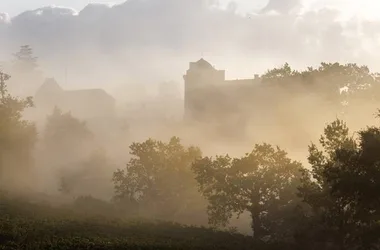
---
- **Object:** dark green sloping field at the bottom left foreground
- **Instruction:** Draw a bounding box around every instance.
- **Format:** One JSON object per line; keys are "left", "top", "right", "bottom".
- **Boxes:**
{"left": 0, "top": 199, "right": 283, "bottom": 250}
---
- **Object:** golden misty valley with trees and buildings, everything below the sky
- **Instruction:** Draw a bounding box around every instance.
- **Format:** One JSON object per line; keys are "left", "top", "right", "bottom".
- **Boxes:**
{"left": 0, "top": 45, "right": 380, "bottom": 250}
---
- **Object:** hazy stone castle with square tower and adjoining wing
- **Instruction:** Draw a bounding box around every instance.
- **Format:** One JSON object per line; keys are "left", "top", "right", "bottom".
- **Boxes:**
{"left": 183, "top": 58, "right": 269, "bottom": 124}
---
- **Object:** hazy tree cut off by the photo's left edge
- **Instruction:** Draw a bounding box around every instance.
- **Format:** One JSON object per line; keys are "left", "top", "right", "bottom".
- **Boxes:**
{"left": 0, "top": 71, "right": 37, "bottom": 186}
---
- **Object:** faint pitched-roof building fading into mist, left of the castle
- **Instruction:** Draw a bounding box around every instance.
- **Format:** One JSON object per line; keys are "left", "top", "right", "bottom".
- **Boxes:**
{"left": 35, "top": 78, "right": 115, "bottom": 120}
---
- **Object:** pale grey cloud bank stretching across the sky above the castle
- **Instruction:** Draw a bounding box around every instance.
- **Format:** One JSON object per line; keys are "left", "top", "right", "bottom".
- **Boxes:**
{"left": 0, "top": 0, "right": 380, "bottom": 98}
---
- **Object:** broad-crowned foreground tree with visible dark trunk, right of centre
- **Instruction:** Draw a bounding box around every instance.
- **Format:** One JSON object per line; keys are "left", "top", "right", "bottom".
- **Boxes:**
{"left": 193, "top": 144, "right": 302, "bottom": 239}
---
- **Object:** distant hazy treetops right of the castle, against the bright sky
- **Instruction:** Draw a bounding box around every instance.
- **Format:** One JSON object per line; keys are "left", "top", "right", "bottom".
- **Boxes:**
{"left": 261, "top": 62, "right": 380, "bottom": 109}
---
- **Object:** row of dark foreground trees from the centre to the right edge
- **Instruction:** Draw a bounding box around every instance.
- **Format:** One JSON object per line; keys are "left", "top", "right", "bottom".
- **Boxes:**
{"left": 110, "top": 120, "right": 380, "bottom": 249}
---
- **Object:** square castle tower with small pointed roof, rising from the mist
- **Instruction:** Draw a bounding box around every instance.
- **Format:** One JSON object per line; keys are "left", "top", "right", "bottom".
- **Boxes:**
{"left": 183, "top": 58, "right": 225, "bottom": 121}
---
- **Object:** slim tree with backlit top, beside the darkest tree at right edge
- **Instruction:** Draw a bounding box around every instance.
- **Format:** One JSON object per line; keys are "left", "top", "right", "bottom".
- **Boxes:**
{"left": 299, "top": 119, "right": 355, "bottom": 246}
